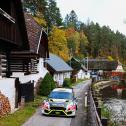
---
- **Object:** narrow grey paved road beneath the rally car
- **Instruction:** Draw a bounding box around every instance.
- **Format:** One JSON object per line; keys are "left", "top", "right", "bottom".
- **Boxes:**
{"left": 22, "top": 80, "right": 91, "bottom": 126}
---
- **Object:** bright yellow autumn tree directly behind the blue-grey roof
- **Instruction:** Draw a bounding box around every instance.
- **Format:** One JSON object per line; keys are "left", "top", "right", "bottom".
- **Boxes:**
{"left": 49, "top": 27, "right": 69, "bottom": 61}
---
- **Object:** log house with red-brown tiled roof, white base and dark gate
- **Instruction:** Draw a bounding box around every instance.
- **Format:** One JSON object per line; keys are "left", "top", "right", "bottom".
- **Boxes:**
{"left": 10, "top": 13, "right": 49, "bottom": 101}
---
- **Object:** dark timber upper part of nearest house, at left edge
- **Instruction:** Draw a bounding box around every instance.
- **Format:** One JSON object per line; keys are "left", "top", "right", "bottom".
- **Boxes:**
{"left": 0, "top": 0, "right": 29, "bottom": 77}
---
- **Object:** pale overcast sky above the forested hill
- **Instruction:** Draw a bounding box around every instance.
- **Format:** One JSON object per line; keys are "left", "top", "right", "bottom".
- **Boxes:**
{"left": 56, "top": 0, "right": 126, "bottom": 35}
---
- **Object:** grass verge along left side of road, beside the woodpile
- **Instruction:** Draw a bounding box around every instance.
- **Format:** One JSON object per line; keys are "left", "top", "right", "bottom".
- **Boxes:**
{"left": 0, "top": 96, "right": 45, "bottom": 126}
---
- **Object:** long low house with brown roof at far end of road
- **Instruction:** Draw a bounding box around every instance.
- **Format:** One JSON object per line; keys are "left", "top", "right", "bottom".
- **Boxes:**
{"left": 82, "top": 58, "right": 118, "bottom": 80}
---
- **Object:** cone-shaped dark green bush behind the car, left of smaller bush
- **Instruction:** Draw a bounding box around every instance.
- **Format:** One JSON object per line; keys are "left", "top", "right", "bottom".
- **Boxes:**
{"left": 39, "top": 73, "right": 56, "bottom": 96}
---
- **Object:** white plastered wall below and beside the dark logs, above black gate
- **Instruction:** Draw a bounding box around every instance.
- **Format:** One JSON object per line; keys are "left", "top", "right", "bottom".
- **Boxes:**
{"left": 12, "top": 58, "right": 48, "bottom": 86}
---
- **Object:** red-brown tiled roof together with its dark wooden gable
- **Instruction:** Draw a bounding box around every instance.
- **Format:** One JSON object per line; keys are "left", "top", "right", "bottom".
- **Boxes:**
{"left": 25, "top": 13, "right": 49, "bottom": 58}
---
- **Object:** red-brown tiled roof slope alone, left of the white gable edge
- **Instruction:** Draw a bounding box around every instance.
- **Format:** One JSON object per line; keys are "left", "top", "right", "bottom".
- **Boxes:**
{"left": 25, "top": 13, "right": 42, "bottom": 53}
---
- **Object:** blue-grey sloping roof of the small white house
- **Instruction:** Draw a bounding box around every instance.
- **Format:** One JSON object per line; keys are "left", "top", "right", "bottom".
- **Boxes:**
{"left": 45, "top": 54, "right": 73, "bottom": 72}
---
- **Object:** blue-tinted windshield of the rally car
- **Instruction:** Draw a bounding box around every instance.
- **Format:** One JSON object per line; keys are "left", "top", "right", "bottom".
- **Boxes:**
{"left": 49, "top": 91, "right": 73, "bottom": 99}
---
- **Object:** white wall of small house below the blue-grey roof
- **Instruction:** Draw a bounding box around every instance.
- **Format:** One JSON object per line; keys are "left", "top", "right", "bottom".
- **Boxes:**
{"left": 53, "top": 72, "right": 71, "bottom": 86}
